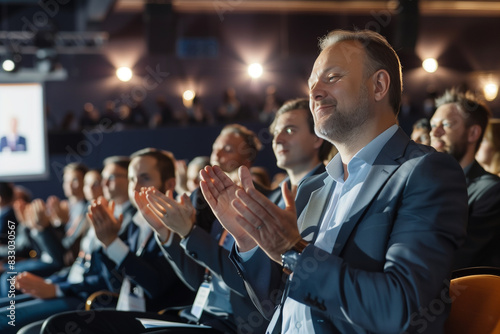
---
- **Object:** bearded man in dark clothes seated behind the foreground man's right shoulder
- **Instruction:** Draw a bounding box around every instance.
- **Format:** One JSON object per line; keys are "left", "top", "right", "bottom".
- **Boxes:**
{"left": 430, "top": 89, "right": 500, "bottom": 269}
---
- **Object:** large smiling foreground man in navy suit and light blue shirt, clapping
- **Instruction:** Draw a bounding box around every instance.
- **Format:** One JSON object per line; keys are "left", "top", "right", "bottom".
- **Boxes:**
{"left": 200, "top": 30, "right": 467, "bottom": 334}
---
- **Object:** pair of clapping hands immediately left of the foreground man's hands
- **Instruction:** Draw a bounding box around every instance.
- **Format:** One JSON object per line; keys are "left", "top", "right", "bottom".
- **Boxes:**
{"left": 135, "top": 187, "right": 191, "bottom": 242}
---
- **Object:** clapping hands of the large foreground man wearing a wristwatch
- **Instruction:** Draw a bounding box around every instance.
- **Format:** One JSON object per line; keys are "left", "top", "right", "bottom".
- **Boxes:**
{"left": 200, "top": 166, "right": 301, "bottom": 264}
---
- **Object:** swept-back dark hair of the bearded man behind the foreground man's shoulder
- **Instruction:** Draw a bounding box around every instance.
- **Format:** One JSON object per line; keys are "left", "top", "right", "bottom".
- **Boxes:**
{"left": 436, "top": 87, "right": 491, "bottom": 151}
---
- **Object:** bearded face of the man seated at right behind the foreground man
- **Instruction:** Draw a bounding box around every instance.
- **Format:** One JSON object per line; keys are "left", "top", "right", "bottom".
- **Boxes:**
{"left": 430, "top": 103, "right": 468, "bottom": 162}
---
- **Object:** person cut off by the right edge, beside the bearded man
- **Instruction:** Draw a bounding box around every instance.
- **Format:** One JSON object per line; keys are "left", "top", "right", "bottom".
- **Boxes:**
{"left": 476, "top": 119, "right": 500, "bottom": 176}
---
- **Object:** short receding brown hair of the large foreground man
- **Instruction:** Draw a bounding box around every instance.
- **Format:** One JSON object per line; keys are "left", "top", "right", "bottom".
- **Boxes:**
{"left": 319, "top": 30, "right": 403, "bottom": 115}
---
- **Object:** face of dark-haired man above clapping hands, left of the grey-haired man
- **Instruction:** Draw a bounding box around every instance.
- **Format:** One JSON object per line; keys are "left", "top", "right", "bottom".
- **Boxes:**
{"left": 128, "top": 156, "right": 171, "bottom": 206}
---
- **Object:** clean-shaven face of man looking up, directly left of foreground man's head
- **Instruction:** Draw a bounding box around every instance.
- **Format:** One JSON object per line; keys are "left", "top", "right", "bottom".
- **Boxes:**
{"left": 273, "top": 109, "right": 323, "bottom": 169}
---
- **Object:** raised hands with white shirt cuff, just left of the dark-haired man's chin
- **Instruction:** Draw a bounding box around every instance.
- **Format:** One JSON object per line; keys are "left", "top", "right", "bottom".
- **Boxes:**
{"left": 87, "top": 197, "right": 123, "bottom": 247}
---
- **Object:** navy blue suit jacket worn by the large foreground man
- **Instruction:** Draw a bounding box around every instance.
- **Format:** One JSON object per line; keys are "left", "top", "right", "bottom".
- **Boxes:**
{"left": 233, "top": 129, "right": 467, "bottom": 334}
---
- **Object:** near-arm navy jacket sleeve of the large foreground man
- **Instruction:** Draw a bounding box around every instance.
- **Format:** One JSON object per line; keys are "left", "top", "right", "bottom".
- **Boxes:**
{"left": 289, "top": 153, "right": 467, "bottom": 333}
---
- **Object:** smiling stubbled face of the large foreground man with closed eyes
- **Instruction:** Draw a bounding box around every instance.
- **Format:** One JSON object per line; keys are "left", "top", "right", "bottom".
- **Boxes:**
{"left": 309, "top": 41, "right": 371, "bottom": 143}
